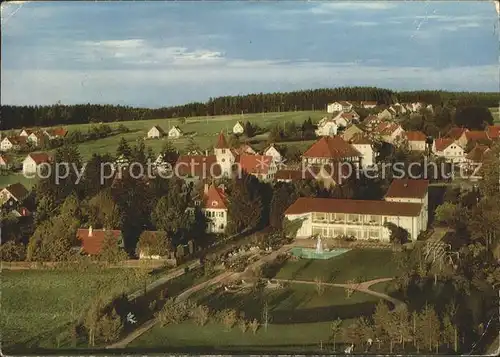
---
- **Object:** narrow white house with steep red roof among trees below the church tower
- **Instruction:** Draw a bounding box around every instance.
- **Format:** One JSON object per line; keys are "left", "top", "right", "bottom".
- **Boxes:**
{"left": 195, "top": 184, "right": 228, "bottom": 233}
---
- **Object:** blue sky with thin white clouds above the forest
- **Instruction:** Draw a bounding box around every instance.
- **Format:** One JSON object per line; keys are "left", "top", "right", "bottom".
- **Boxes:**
{"left": 1, "top": 0, "right": 500, "bottom": 107}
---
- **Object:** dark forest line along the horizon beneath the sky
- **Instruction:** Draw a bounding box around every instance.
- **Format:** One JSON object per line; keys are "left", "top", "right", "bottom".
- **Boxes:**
{"left": 0, "top": 87, "right": 500, "bottom": 130}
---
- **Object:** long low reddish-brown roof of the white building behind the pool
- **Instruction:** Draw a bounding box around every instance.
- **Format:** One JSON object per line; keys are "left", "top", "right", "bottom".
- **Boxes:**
{"left": 285, "top": 197, "right": 422, "bottom": 217}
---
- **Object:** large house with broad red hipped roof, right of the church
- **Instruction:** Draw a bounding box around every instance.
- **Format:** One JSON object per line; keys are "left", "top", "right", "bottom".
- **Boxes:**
{"left": 302, "top": 136, "right": 363, "bottom": 166}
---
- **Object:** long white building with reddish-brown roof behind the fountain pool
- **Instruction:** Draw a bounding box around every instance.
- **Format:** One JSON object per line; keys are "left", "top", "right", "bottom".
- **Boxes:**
{"left": 285, "top": 178, "right": 428, "bottom": 242}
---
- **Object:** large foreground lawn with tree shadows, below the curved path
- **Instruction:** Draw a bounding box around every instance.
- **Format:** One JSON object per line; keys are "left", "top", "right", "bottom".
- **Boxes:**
{"left": 127, "top": 284, "right": 378, "bottom": 353}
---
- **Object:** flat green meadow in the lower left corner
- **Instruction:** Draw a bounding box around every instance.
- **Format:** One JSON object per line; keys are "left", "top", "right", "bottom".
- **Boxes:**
{"left": 0, "top": 269, "right": 146, "bottom": 349}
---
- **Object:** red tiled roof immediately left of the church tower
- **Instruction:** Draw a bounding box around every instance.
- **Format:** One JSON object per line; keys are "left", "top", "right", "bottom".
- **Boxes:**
{"left": 174, "top": 155, "right": 222, "bottom": 178}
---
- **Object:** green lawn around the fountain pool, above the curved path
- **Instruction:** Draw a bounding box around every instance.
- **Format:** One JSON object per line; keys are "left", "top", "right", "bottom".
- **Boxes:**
{"left": 276, "top": 249, "right": 398, "bottom": 283}
